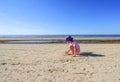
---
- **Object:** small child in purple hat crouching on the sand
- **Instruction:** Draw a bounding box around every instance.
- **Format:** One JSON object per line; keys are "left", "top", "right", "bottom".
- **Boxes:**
{"left": 65, "top": 36, "right": 80, "bottom": 57}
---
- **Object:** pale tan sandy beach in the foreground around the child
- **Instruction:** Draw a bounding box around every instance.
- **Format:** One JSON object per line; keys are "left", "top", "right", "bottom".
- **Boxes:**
{"left": 0, "top": 44, "right": 120, "bottom": 82}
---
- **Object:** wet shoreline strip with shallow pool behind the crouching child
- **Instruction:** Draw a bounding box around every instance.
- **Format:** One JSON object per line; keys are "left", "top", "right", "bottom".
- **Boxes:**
{"left": 0, "top": 37, "right": 120, "bottom": 44}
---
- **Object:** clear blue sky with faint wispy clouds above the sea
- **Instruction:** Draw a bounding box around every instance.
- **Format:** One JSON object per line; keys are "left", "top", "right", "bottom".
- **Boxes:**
{"left": 0, "top": 0, "right": 120, "bottom": 35}
